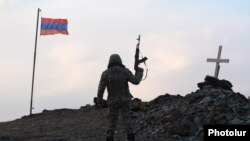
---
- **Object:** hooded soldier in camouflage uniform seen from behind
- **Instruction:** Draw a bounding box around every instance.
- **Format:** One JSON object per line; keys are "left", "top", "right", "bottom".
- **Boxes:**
{"left": 97, "top": 54, "right": 143, "bottom": 141}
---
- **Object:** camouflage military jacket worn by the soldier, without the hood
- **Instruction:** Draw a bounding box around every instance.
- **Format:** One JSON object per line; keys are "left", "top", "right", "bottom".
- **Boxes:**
{"left": 97, "top": 66, "right": 143, "bottom": 105}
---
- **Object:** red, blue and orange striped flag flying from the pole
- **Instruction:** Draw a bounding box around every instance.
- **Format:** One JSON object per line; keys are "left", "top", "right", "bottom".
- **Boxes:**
{"left": 40, "top": 18, "right": 69, "bottom": 35}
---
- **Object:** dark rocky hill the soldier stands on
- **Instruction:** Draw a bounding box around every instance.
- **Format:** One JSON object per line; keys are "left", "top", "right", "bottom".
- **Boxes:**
{"left": 0, "top": 76, "right": 250, "bottom": 141}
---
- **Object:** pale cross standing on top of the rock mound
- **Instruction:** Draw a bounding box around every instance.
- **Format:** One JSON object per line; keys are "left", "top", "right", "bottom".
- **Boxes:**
{"left": 207, "top": 46, "right": 229, "bottom": 78}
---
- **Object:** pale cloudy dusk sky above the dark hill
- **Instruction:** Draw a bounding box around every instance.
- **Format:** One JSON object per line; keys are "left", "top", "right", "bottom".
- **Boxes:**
{"left": 0, "top": 0, "right": 250, "bottom": 122}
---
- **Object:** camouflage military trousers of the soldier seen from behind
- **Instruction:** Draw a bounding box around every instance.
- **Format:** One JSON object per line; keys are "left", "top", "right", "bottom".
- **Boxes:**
{"left": 107, "top": 102, "right": 133, "bottom": 136}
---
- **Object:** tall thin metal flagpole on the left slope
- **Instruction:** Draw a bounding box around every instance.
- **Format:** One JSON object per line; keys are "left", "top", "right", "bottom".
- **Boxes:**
{"left": 30, "top": 8, "right": 41, "bottom": 115}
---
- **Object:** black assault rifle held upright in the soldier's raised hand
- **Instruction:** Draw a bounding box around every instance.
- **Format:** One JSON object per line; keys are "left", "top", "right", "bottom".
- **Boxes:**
{"left": 134, "top": 35, "right": 148, "bottom": 80}
